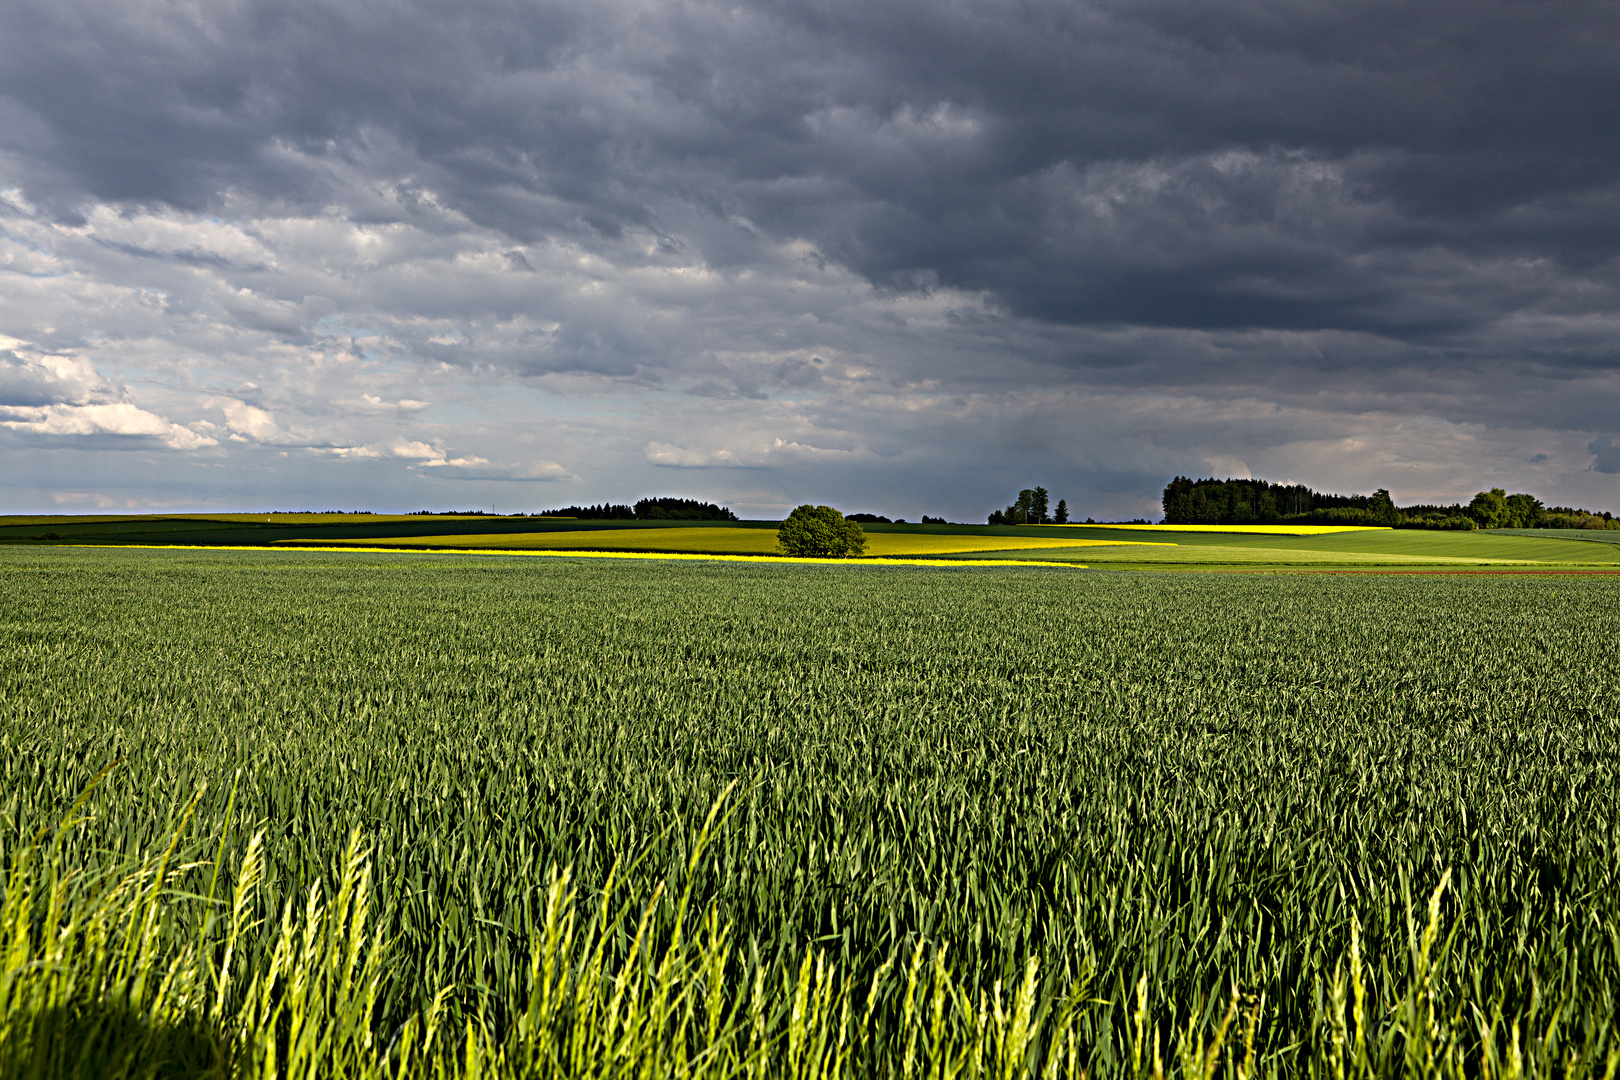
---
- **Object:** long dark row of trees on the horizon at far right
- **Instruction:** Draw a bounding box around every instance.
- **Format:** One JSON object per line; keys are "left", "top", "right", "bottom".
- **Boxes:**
{"left": 1165, "top": 476, "right": 1620, "bottom": 529}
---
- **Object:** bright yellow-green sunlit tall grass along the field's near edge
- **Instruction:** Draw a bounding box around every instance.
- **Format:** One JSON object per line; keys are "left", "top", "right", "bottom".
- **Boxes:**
{"left": 9, "top": 780, "right": 1620, "bottom": 1080}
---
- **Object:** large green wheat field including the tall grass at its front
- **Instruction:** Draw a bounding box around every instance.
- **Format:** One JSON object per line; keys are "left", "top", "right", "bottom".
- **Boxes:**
{"left": 0, "top": 550, "right": 1620, "bottom": 1080}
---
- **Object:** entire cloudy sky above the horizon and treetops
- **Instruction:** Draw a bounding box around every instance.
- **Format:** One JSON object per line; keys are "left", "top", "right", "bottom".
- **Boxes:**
{"left": 0, "top": 0, "right": 1620, "bottom": 521}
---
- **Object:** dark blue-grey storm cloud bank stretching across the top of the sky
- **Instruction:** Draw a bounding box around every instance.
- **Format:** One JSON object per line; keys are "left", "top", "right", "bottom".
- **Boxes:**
{"left": 0, "top": 0, "right": 1620, "bottom": 340}
